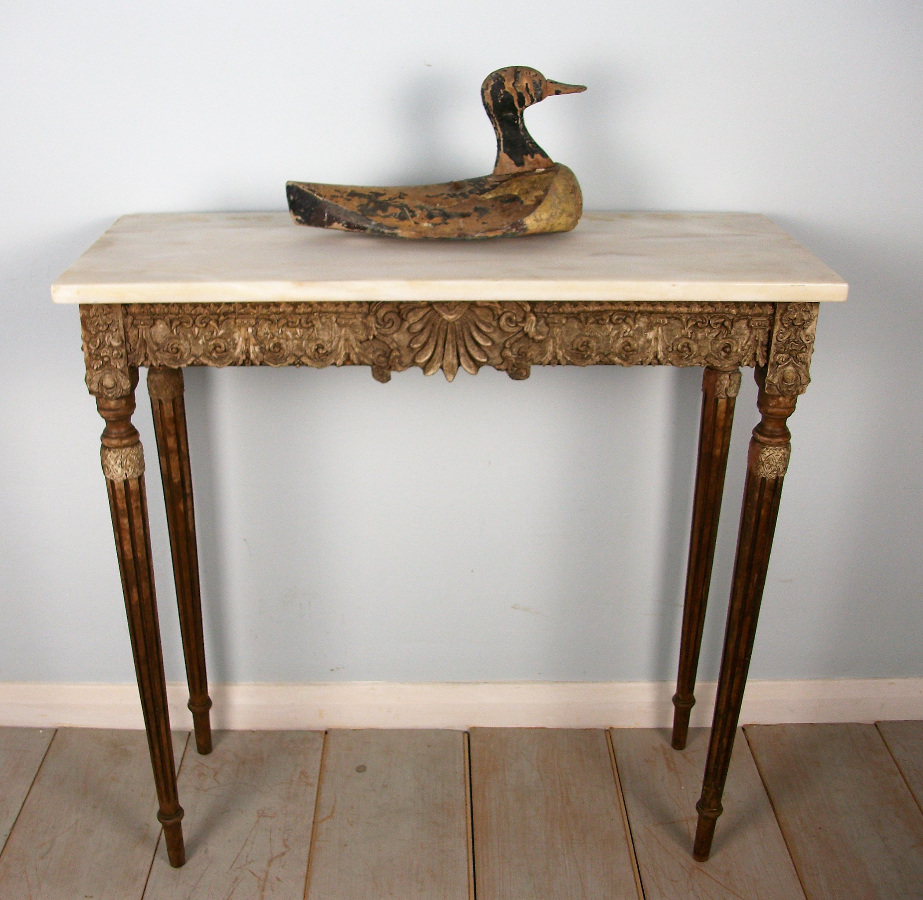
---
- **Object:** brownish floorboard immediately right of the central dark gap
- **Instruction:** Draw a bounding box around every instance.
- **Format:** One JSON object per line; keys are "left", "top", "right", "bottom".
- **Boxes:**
{"left": 470, "top": 728, "right": 638, "bottom": 900}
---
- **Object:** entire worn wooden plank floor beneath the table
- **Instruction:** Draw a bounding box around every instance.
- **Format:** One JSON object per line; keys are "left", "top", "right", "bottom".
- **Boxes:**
{"left": 0, "top": 722, "right": 923, "bottom": 900}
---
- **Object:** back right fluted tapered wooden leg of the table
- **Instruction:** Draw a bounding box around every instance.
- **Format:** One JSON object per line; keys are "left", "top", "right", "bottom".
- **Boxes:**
{"left": 673, "top": 368, "right": 740, "bottom": 750}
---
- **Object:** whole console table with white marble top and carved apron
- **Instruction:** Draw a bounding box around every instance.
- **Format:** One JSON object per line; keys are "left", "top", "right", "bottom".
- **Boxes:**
{"left": 52, "top": 213, "right": 847, "bottom": 866}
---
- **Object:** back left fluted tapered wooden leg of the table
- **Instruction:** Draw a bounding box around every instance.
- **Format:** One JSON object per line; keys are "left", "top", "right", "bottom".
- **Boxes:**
{"left": 147, "top": 366, "right": 212, "bottom": 753}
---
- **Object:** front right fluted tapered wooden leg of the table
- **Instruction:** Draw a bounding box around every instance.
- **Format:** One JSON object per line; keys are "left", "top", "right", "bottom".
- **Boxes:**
{"left": 692, "top": 369, "right": 796, "bottom": 860}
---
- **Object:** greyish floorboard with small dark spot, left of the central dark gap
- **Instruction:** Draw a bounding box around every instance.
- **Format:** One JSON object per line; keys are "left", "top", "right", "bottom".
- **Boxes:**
{"left": 305, "top": 731, "right": 471, "bottom": 900}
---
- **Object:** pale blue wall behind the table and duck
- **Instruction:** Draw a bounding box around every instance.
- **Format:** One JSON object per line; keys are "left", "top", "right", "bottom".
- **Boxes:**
{"left": 0, "top": 0, "right": 923, "bottom": 682}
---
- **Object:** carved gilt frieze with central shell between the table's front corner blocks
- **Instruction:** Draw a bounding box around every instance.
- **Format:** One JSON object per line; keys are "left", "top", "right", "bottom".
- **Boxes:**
{"left": 97, "top": 301, "right": 774, "bottom": 381}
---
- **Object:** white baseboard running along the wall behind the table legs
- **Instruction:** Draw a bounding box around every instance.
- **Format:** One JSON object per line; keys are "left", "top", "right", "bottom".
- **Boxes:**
{"left": 0, "top": 678, "right": 923, "bottom": 730}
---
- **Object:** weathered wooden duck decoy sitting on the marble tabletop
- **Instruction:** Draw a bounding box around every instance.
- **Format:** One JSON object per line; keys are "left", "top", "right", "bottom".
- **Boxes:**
{"left": 287, "top": 66, "right": 586, "bottom": 239}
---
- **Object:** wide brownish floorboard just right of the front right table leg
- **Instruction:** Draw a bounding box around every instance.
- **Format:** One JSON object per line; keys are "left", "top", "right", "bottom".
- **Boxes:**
{"left": 746, "top": 724, "right": 923, "bottom": 900}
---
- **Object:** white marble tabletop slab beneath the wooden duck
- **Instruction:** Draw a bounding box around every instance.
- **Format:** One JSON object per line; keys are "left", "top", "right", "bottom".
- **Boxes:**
{"left": 51, "top": 213, "right": 847, "bottom": 303}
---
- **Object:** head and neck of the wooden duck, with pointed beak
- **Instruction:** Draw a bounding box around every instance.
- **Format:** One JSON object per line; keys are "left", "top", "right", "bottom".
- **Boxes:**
{"left": 481, "top": 66, "right": 586, "bottom": 175}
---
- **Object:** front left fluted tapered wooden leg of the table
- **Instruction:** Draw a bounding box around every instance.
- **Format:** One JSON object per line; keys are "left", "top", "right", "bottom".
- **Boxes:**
{"left": 96, "top": 369, "right": 185, "bottom": 866}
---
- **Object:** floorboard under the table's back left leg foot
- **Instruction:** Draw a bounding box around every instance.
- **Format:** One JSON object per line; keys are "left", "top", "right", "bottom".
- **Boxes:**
{"left": 144, "top": 731, "right": 324, "bottom": 900}
